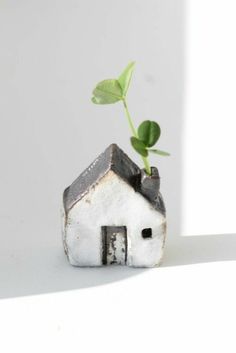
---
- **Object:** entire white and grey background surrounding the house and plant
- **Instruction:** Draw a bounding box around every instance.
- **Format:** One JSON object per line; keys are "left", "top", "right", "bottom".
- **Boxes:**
{"left": 0, "top": 0, "right": 236, "bottom": 353}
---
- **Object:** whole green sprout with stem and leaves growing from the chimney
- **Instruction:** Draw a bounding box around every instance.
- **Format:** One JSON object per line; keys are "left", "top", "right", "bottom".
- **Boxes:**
{"left": 92, "top": 62, "right": 169, "bottom": 175}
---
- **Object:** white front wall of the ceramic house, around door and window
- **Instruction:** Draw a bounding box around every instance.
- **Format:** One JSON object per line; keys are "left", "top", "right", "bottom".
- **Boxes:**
{"left": 65, "top": 171, "right": 165, "bottom": 267}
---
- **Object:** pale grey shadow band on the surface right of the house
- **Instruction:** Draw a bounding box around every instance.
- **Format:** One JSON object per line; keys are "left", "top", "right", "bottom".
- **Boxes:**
{"left": 162, "top": 234, "right": 236, "bottom": 267}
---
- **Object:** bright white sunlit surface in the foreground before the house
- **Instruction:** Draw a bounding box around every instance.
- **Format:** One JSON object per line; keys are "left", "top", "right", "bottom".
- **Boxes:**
{"left": 0, "top": 262, "right": 236, "bottom": 353}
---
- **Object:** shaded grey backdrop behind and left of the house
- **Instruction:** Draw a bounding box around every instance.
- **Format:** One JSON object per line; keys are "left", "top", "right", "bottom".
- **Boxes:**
{"left": 0, "top": 0, "right": 185, "bottom": 296}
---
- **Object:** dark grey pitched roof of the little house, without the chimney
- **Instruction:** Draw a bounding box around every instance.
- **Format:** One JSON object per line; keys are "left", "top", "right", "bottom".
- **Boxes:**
{"left": 63, "top": 144, "right": 165, "bottom": 214}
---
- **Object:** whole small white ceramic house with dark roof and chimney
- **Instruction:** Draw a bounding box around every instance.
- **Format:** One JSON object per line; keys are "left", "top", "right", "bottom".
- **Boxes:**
{"left": 63, "top": 144, "right": 166, "bottom": 267}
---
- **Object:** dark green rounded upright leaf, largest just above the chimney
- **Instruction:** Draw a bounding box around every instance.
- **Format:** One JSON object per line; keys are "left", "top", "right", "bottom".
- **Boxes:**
{"left": 138, "top": 120, "right": 161, "bottom": 147}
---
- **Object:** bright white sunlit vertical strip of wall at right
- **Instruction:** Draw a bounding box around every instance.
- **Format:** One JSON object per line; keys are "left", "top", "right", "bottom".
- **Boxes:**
{"left": 183, "top": 0, "right": 236, "bottom": 235}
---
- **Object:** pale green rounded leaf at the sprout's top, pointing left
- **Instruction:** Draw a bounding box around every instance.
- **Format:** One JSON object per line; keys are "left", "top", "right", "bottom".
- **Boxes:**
{"left": 92, "top": 79, "right": 122, "bottom": 104}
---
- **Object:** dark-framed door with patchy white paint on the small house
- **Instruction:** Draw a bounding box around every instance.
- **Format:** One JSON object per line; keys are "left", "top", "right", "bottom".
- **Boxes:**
{"left": 102, "top": 226, "right": 127, "bottom": 265}
